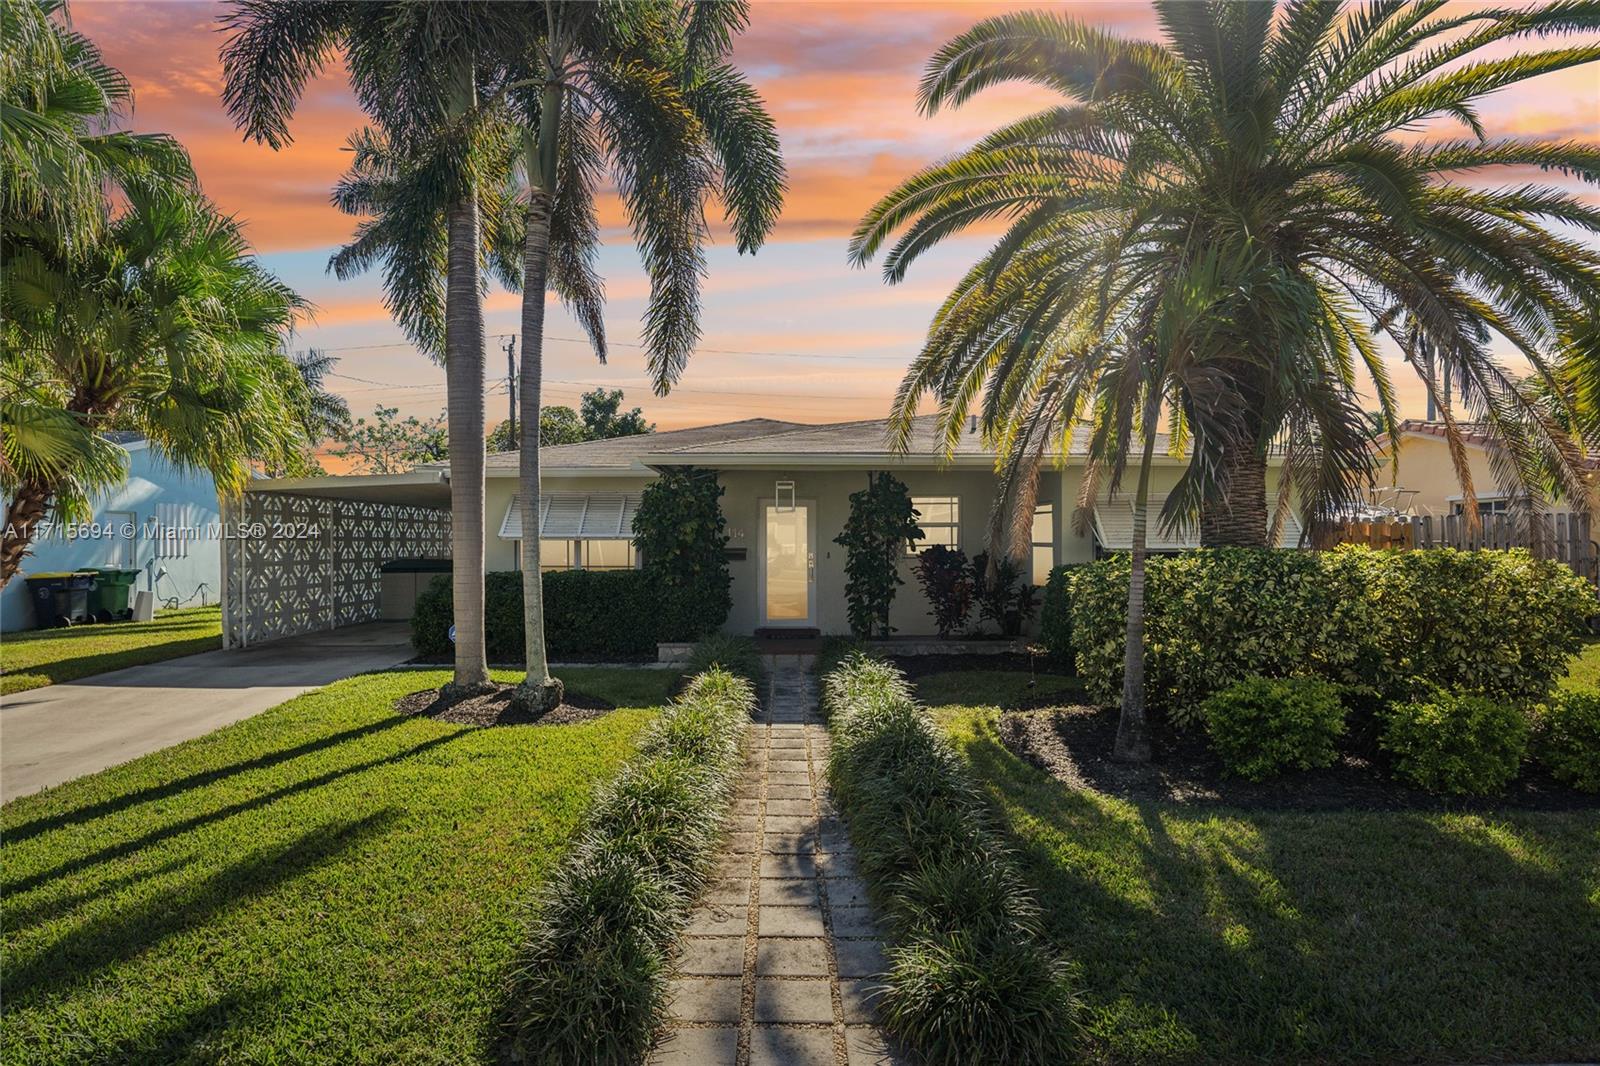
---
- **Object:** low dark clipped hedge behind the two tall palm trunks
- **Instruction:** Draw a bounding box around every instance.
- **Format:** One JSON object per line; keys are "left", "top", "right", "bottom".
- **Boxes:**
{"left": 411, "top": 570, "right": 706, "bottom": 663}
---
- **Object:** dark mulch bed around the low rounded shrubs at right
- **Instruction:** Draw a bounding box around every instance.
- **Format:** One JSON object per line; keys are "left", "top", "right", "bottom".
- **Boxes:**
{"left": 1000, "top": 706, "right": 1600, "bottom": 812}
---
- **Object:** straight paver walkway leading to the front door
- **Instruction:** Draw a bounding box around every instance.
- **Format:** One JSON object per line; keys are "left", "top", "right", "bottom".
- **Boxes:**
{"left": 650, "top": 659, "right": 898, "bottom": 1066}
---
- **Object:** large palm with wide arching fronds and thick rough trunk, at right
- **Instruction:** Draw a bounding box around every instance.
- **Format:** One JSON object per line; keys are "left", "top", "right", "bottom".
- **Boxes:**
{"left": 851, "top": 0, "right": 1600, "bottom": 546}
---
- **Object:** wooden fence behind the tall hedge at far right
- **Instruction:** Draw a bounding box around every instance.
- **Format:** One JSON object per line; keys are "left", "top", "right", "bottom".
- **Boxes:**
{"left": 1323, "top": 512, "right": 1600, "bottom": 584}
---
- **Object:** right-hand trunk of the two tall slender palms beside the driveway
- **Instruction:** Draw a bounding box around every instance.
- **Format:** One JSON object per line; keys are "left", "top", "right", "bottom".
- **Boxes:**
{"left": 517, "top": 95, "right": 565, "bottom": 714}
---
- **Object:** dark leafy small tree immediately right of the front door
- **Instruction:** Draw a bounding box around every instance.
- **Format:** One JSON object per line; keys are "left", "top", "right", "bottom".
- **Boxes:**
{"left": 834, "top": 472, "right": 922, "bottom": 637}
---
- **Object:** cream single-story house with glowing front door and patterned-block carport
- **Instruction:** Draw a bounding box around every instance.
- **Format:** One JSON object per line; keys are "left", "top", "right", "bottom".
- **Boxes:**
{"left": 224, "top": 418, "right": 1299, "bottom": 643}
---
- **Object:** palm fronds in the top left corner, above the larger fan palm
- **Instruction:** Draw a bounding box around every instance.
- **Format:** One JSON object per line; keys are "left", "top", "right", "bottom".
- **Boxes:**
{"left": 0, "top": 0, "right": 194, "bottom": 248}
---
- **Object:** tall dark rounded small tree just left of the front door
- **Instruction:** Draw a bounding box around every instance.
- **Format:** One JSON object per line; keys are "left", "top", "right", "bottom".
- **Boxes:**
{"left": 634, "top": 466, "right": 733, "bottom": 640}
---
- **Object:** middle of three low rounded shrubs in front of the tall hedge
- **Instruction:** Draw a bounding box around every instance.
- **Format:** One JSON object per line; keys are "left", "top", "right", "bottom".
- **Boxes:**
{"left": 1379, "top": 691, "right": 1528, "bottom": 795}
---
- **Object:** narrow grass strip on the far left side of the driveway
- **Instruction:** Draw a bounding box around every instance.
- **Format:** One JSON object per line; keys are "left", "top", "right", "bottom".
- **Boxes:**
{"left": 0, "top": 607, "right": 222, "bottom": 695}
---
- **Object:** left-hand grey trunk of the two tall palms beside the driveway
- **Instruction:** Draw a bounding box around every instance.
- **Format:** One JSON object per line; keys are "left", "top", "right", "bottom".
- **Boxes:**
{"left": 445, "top": 64, "right": 491, "bottom": 696}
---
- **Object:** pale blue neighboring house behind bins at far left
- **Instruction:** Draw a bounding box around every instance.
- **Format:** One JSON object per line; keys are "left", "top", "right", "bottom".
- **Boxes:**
{"left": 0, "top": 434, "right": 222, "bottom": 632}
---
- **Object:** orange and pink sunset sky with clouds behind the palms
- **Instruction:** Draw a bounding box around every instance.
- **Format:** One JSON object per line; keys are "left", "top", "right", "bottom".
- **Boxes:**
{"left": 72, "top": 0, "right": 1600, "bottom": 429}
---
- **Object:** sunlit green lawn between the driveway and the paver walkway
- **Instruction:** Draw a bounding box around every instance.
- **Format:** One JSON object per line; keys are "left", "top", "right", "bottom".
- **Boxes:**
{"left": 0, "top": 669, "right": 672, "bottom": 1066}
